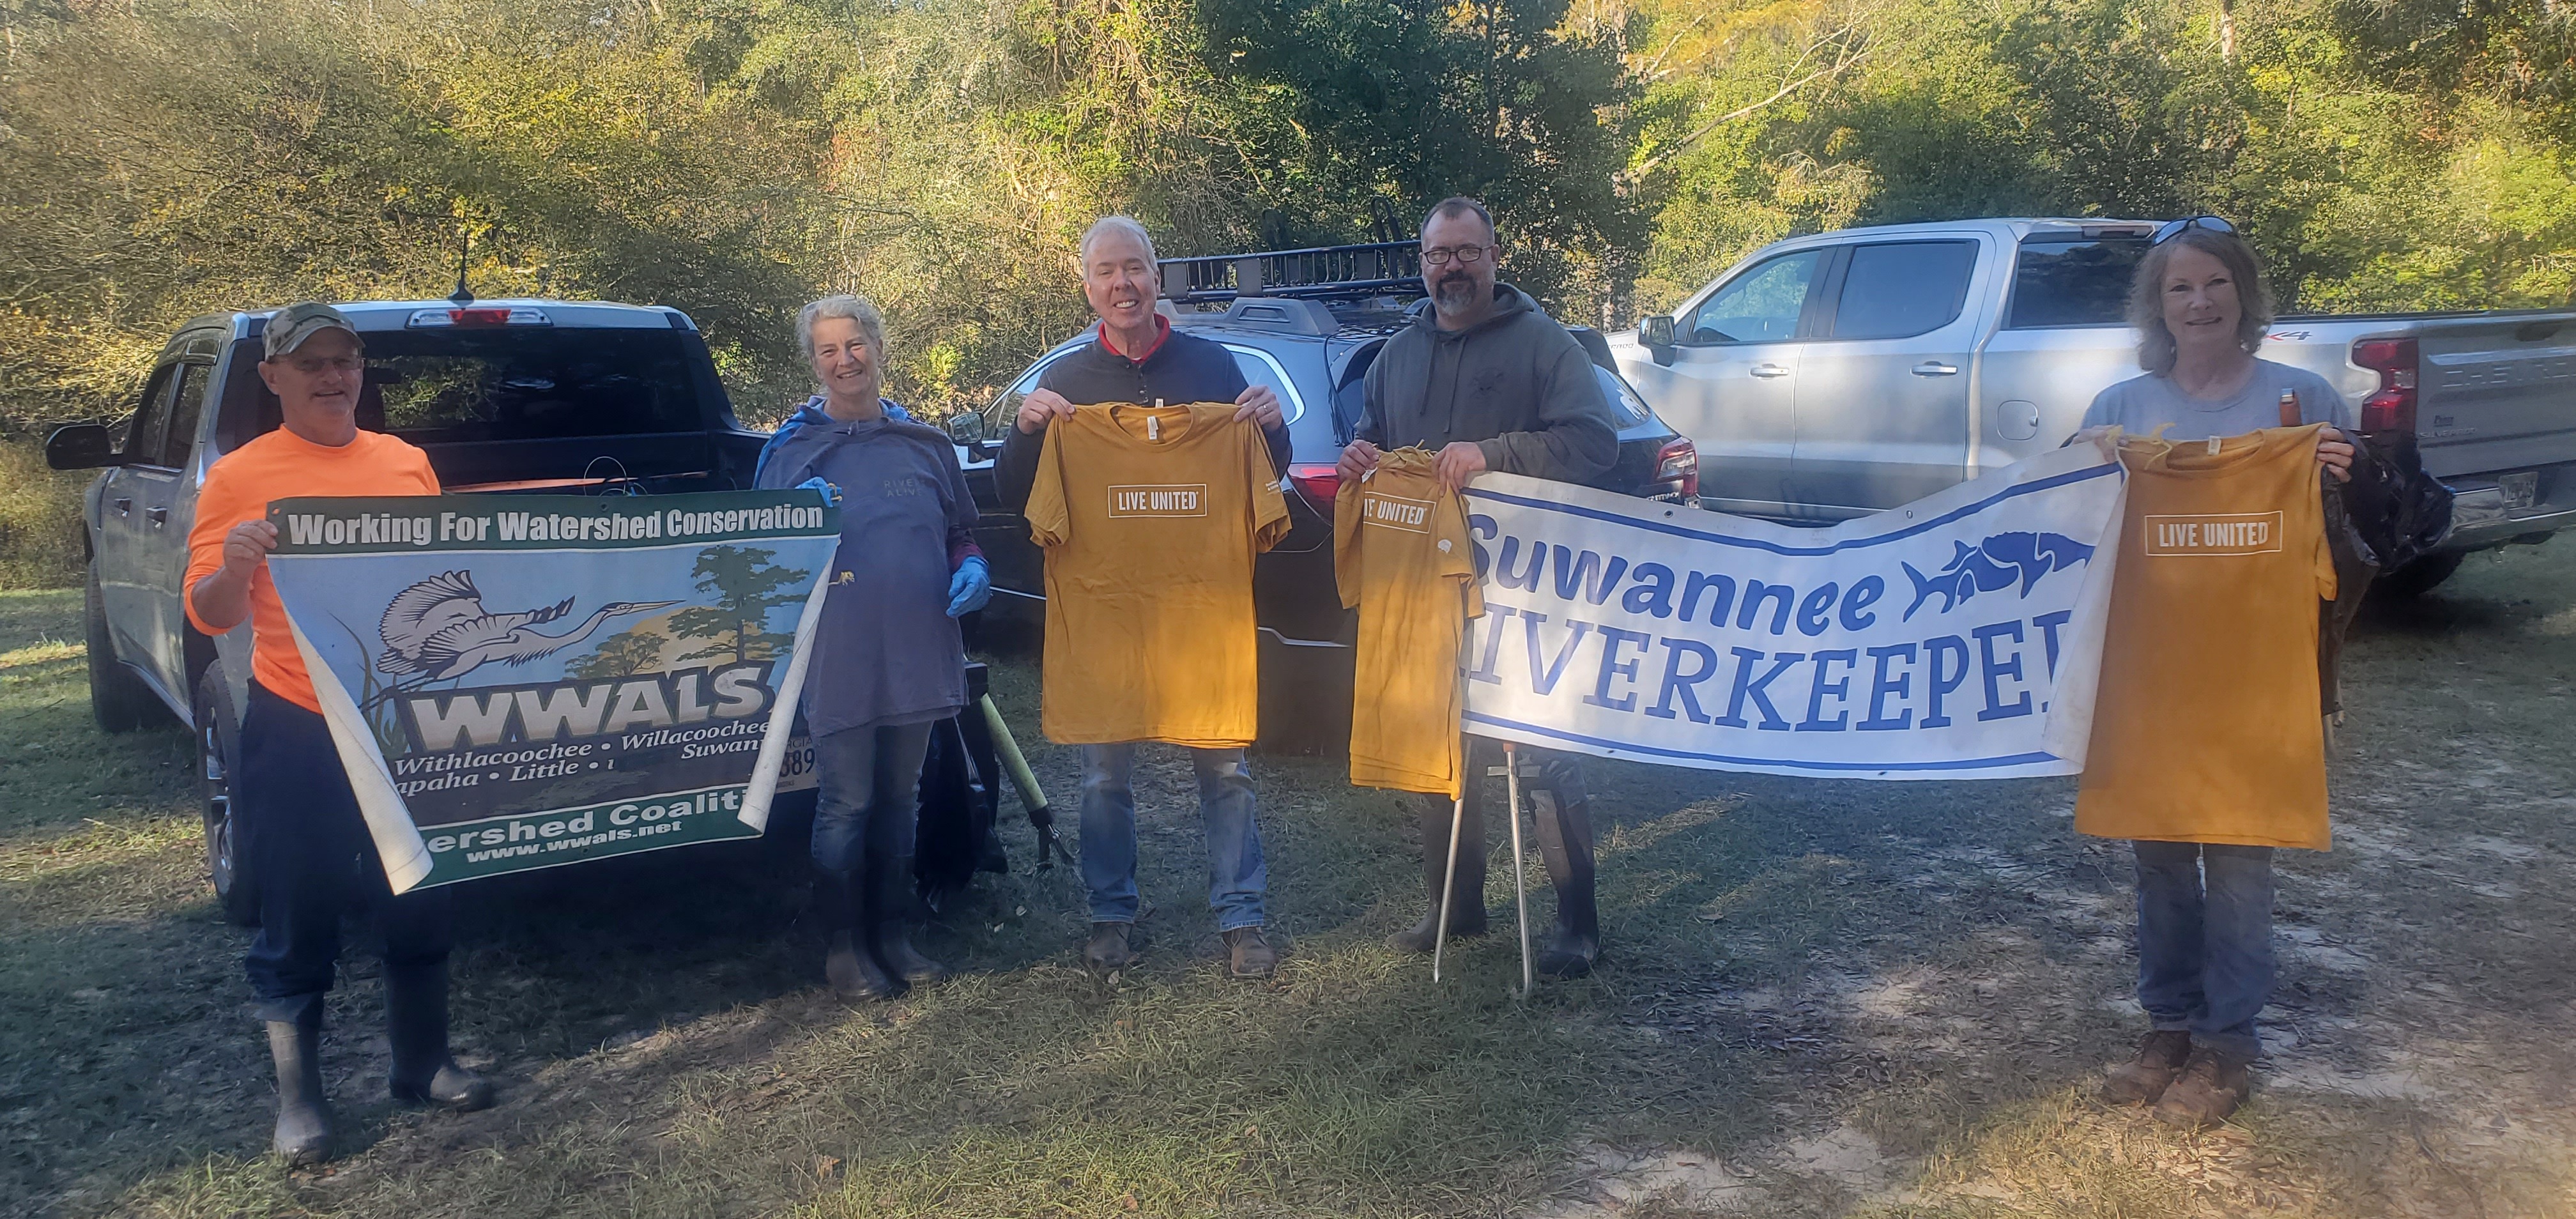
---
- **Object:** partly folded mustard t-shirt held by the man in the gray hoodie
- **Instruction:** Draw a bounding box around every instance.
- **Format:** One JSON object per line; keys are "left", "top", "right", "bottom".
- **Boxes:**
{"left": 1332, "top": 448, "right": 1483, "bottom": 799}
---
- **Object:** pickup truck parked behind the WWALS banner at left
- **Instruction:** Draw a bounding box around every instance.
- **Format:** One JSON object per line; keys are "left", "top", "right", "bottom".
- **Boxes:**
{"left": 47, "top": 299, "right": 811, "bottom": 920}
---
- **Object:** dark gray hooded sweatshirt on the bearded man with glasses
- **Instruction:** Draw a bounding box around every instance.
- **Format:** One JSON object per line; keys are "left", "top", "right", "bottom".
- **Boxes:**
{"left": 1358, "top": 284, "right": 1618, "bottom": 482}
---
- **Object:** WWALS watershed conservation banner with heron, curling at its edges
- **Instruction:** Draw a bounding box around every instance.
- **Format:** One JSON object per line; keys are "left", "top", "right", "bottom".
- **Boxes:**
{"left": 268, "top": 492, "right": 839, "bottom": 892}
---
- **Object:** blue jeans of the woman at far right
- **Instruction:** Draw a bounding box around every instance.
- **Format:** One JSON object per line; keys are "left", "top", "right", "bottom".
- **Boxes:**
{"left": 2133, "top": 840, "right": 2272, "bottom": 1062}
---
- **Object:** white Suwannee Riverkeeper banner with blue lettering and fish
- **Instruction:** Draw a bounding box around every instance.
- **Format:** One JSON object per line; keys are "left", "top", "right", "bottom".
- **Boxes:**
{"left": 1460, "top": 446, "right": 2125, "bottom": 778}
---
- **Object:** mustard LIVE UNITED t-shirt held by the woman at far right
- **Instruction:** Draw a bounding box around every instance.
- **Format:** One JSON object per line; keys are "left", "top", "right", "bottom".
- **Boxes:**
{"left": 2076, "top": 425, "right": 2334, "bottom": 850}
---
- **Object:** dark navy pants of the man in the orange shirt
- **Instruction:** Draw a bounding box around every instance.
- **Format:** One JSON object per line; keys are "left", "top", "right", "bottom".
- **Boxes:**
{"left": 232, "top": 683, "right": 454, "bottom": 1020}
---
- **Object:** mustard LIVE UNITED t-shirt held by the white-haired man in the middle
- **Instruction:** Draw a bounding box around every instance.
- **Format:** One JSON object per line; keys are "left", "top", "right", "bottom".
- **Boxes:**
{"left": 1028, "top": 402, "right": 1288, "bottom": 750}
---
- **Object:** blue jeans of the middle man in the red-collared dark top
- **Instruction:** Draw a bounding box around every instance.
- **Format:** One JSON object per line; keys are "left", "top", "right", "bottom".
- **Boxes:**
{"left": 1082, "top": 745, "right": 1270, "bottom": 930}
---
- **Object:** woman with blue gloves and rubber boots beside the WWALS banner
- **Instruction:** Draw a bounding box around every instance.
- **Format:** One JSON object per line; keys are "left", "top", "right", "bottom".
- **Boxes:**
{"left": 757, "top": 296, "right": 992, "bottom": 1000}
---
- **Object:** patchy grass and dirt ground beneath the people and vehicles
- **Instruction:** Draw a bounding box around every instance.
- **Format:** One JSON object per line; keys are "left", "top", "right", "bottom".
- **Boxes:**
{"left": 0, "top": 541, "right": 2576, "bottom": 1219}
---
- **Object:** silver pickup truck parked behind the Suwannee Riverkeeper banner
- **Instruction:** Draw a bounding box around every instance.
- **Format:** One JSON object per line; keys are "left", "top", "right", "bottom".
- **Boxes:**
{"left": 1610, "top": 219, "right": 2576, "bottom": 593}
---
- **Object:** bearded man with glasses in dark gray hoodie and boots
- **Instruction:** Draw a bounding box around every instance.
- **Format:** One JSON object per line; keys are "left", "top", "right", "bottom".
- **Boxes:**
{"left": 1340, "top": 196, "right": 1618, "bottom": 977}
